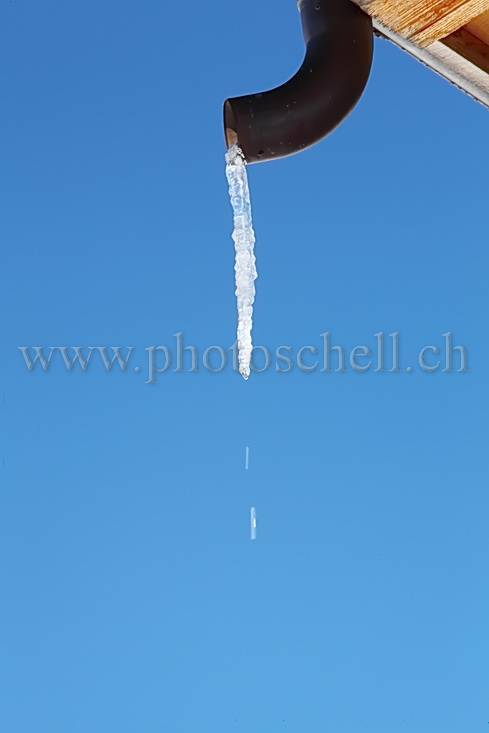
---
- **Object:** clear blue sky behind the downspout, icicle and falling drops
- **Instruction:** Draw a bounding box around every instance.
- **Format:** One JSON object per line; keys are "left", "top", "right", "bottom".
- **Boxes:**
{"left": 0, "top": 0, "right": 489, "bottom": 733}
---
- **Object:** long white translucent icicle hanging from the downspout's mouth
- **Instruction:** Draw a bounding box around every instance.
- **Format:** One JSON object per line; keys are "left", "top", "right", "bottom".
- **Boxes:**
{"left": 226, "top": 143, "right": 257, "bottom": 379}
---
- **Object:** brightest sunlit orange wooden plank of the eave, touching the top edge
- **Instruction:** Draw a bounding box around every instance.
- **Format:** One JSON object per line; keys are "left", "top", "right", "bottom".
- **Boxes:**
{"left": 357, "top": 0, "right": 489, "bottom": 47}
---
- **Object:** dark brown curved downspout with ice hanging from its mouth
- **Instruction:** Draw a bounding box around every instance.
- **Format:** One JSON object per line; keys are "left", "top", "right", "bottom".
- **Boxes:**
{"left": 224, "top": 0, "right": 373, "bottom": 163}
